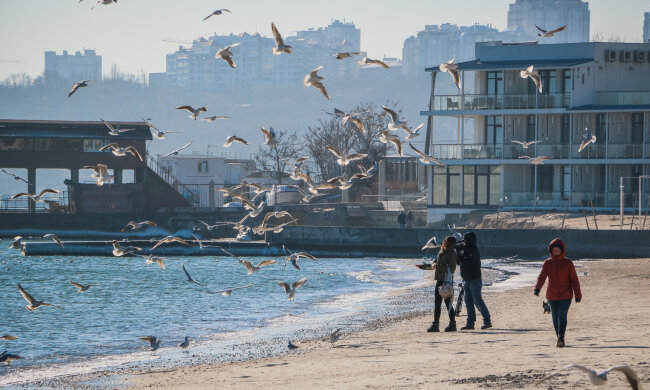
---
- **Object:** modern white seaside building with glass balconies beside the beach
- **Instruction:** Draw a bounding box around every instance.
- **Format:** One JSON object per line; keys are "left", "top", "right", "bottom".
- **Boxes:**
{"left": 421, "top": 42, "right": 650, "bottom": 222}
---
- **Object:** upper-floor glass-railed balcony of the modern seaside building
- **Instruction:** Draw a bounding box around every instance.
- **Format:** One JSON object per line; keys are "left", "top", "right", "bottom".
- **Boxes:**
{"left": 431, "top": 94, "right": 570, "bottom": 111}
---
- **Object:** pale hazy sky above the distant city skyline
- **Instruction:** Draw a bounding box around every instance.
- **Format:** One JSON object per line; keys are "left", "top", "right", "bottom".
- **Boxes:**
{"left": 0, "top": 0, "right": 650, "bottom": 79}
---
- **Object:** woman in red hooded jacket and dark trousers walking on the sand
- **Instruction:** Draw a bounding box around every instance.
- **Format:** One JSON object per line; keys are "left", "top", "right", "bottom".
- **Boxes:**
{"left": 534, "top": 238, "right": 582, "bottom": 348}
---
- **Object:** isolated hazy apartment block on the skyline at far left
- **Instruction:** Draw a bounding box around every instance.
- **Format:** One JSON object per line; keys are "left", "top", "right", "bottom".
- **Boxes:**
{"left": 44, "top": 50, "right": 102, "bottom": 82}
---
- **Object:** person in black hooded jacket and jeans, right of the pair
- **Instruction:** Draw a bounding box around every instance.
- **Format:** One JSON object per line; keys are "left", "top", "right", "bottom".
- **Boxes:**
{"left": 456, "top": 232, "right": 492, "bottom": 330}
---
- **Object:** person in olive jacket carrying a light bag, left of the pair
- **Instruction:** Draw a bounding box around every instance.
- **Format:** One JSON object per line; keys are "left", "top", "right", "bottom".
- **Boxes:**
{"left": 427, "top": 236, "right": 458, "bottom": 332}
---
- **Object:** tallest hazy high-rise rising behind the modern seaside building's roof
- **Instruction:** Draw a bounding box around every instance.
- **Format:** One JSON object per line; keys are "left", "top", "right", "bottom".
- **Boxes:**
{"left": 508, "top": 0, "right": 589, "bottom": 43}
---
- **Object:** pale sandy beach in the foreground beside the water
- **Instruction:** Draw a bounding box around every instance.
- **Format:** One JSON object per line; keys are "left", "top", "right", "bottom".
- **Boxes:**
{"left": 116, "top": 259, "right": 650, "bottom": 389}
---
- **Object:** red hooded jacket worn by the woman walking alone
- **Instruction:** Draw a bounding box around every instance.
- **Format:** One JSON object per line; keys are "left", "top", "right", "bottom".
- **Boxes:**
{"left": 535, "top": 238, "right": 582, "bottom": 301}
